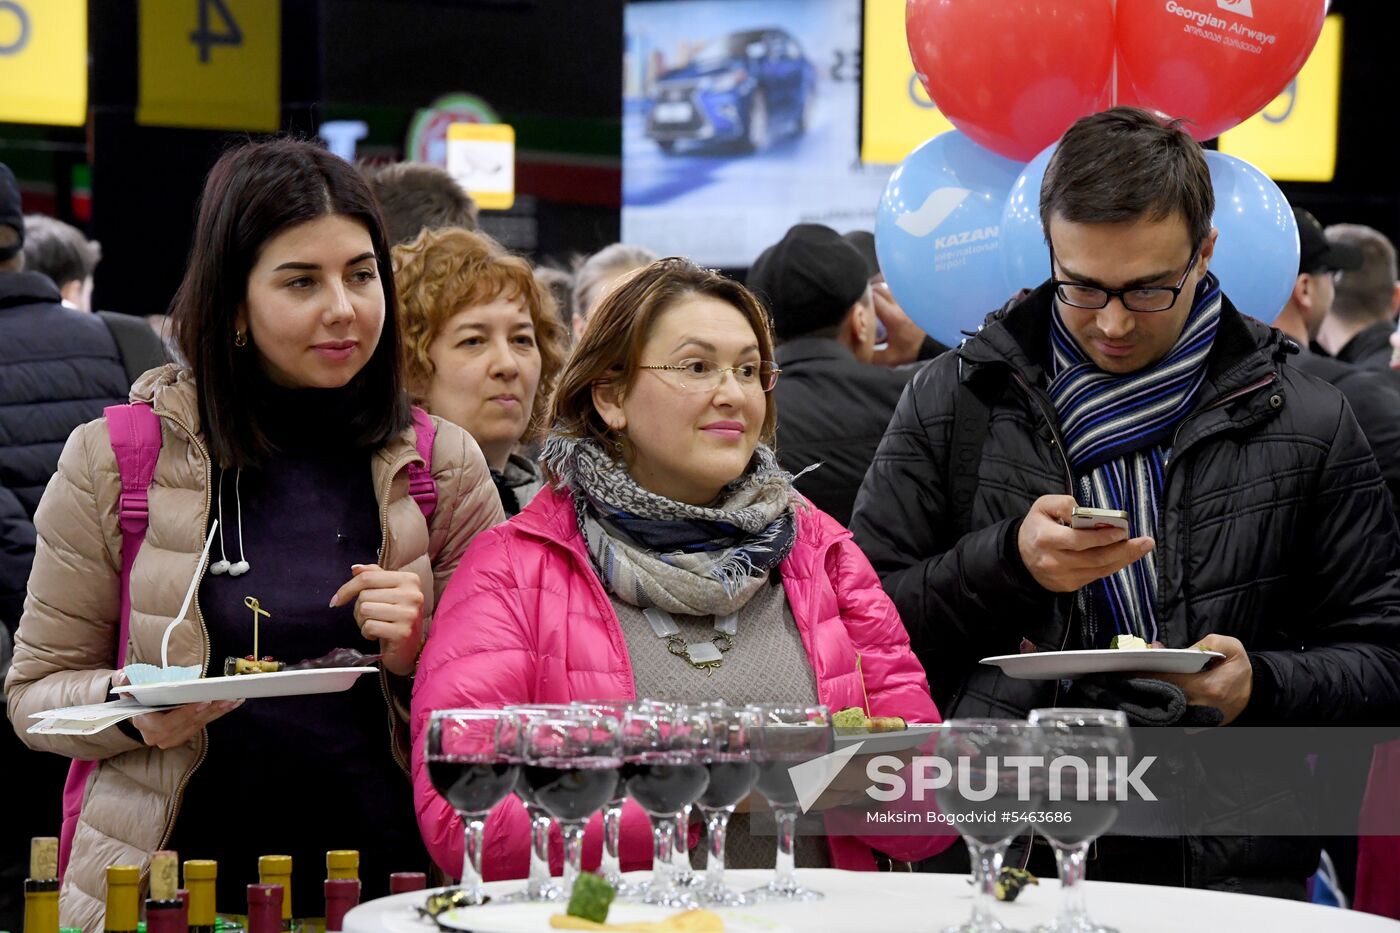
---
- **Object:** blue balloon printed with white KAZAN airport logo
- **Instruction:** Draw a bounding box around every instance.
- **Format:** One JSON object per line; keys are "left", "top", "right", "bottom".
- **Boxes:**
{"left": 875, "top": 130, "right": 1021, "bottom": 345}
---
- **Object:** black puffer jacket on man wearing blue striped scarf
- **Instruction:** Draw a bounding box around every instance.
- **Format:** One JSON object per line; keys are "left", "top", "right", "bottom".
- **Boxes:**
{"left": 851, "top": 286, "right": 1400, "bottom": 895}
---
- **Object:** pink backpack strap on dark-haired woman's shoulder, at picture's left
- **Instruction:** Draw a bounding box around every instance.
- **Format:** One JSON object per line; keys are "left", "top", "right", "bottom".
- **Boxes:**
{"left": 59, "top": 402, "right": 161, "bottom": 877}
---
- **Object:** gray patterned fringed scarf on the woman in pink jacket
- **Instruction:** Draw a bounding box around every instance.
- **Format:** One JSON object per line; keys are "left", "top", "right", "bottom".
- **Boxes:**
{"left": 540, "top": 434, "right": 801, "bottom": 615}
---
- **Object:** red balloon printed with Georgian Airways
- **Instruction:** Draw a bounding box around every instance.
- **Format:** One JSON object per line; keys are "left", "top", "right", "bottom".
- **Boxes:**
{"left": 1117, "top": 0, "right": 1327, "bottom": 140}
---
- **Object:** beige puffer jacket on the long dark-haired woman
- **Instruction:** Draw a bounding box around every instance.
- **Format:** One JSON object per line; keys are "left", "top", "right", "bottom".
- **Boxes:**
{"left": 4, "top": 366, "right": 504, "bottom": 933}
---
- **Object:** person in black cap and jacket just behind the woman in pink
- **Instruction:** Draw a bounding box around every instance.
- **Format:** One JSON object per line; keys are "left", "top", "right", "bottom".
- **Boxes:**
{"left": 748, "top": 218, "right": 914, "bottom": 525}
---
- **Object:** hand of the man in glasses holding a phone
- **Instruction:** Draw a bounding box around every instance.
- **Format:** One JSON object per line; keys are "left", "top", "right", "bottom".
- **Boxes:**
{"left": 1016, "top": 496, "right": 1156, "bottom": 593}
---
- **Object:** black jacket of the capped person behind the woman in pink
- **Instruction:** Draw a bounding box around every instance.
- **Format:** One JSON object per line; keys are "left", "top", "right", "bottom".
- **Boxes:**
{"left": 773, "top": 336, "right": 916, "bottom": 525}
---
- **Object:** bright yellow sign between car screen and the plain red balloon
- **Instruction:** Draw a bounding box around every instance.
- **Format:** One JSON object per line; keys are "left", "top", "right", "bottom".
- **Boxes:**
{"left": 861, "top": 0, "right": 953, "bottom": 165}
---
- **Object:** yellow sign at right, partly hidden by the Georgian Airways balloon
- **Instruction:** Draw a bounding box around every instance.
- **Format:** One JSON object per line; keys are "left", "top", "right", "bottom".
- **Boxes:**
{"left": 1219, "top": 15, "right": 1341, "bottom": 182}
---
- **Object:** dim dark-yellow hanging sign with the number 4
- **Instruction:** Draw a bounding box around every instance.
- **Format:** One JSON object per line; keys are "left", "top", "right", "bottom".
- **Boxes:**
{"left": 136, "top": 0, "right": 281, "bottom": 132}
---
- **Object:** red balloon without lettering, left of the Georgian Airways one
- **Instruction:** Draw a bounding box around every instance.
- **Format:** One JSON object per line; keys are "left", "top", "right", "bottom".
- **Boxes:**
{"left": 904, "top": 0, "right": 1114, "bottom": 163}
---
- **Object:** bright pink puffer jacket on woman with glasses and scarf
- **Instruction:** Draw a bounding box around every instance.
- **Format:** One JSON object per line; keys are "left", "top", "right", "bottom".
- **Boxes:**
{"left": 412, "top": 488, "right": 953, "bottom": 880}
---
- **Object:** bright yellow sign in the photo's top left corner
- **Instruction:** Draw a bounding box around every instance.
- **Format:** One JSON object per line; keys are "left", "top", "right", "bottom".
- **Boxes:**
{"left": 0, "top": 0, "right": 87, "bottom": 126}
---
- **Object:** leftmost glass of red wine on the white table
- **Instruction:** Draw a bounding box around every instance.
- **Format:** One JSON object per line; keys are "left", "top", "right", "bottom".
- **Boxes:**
{"left": 424, "top": 709, "right": 521, "bottom": 905}
